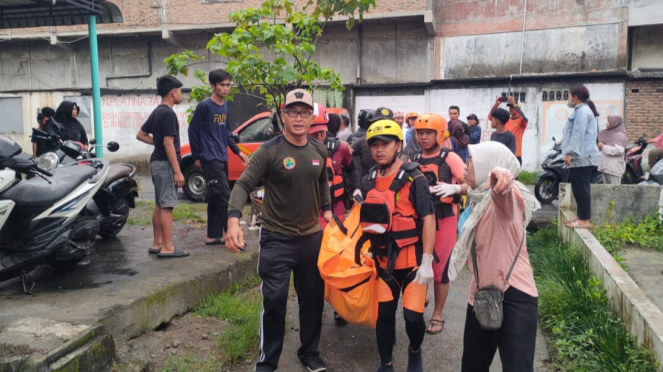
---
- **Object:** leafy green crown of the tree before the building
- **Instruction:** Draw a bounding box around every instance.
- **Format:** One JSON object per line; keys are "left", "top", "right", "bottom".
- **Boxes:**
{"left": 164, "top": 0, "right": 375, "bottom": 120}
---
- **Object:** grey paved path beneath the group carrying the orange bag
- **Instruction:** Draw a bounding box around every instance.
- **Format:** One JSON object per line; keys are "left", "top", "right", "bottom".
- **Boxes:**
{"left": 245, "top": 270, "right": 548, "bottom": 372}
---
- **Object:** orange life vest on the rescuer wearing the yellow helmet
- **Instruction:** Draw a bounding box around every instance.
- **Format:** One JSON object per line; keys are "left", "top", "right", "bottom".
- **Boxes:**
{"left": 359, "top": 163, "right": 423, "bottom": 280}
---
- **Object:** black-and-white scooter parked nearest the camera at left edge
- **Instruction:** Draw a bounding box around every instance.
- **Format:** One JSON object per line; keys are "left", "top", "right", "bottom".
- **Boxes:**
{"left": 0, "top": 135, "right": 109, "bottom": 294}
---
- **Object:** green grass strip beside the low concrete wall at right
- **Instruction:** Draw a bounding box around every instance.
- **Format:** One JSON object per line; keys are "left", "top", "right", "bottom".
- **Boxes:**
{"left": 528, "top": 228, "right": 659, "bottom": 372}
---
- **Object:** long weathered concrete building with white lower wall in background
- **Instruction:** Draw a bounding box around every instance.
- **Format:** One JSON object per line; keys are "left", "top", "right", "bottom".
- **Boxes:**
{"left": 0, "top": 0, "right": 663, "bottom": 170}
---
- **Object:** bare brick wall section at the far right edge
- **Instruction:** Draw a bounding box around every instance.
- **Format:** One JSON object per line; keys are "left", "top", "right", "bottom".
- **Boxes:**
{"left": 624, "top": 80, "right": 663, "bottom": 141}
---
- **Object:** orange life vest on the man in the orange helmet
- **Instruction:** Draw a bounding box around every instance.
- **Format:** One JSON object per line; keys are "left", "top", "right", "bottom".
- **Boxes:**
{"left": 412, "top": 147, "right": 458, "bottom": 219}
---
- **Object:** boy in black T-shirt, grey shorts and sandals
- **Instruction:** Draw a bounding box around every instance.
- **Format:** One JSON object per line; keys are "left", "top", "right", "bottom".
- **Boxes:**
{"left": 136, "top": 75, "right": 189, "bottom": 258}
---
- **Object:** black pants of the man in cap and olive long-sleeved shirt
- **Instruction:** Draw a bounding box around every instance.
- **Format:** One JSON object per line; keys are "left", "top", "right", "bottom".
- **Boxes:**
{"left": 256, "top": 229, "right": 325, "bottom": 370}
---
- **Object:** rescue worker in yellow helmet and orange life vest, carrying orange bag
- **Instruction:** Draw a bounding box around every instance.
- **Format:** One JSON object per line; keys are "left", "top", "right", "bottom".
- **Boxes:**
{"left": 360, "top": 119, "right": 435, "bottom": 372}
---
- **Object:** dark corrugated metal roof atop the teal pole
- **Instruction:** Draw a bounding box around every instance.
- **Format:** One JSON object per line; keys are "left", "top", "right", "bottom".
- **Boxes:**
{"left": 0, "top": 0, "right": 122, "bottom": 29}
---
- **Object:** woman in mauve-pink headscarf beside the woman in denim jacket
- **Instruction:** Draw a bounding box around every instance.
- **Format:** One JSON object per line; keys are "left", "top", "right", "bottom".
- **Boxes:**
{"left": 598, "top": 115, "right": 628, "bottom": 185}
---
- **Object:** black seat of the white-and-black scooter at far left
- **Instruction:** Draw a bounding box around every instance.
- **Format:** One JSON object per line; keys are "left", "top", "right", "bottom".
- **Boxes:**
{"left": 0, "top": 166, "right": 97, "bottom": 208}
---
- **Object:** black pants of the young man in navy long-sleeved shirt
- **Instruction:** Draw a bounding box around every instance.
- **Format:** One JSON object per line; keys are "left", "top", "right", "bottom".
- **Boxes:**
{"left": 200, "top": 160, "right": 230, "bottom": 238}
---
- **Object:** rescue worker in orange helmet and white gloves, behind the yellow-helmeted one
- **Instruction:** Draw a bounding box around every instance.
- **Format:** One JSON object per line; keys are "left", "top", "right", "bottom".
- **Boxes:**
{"left": 412, "top": 114, "right": 467, "bottom": 334}
